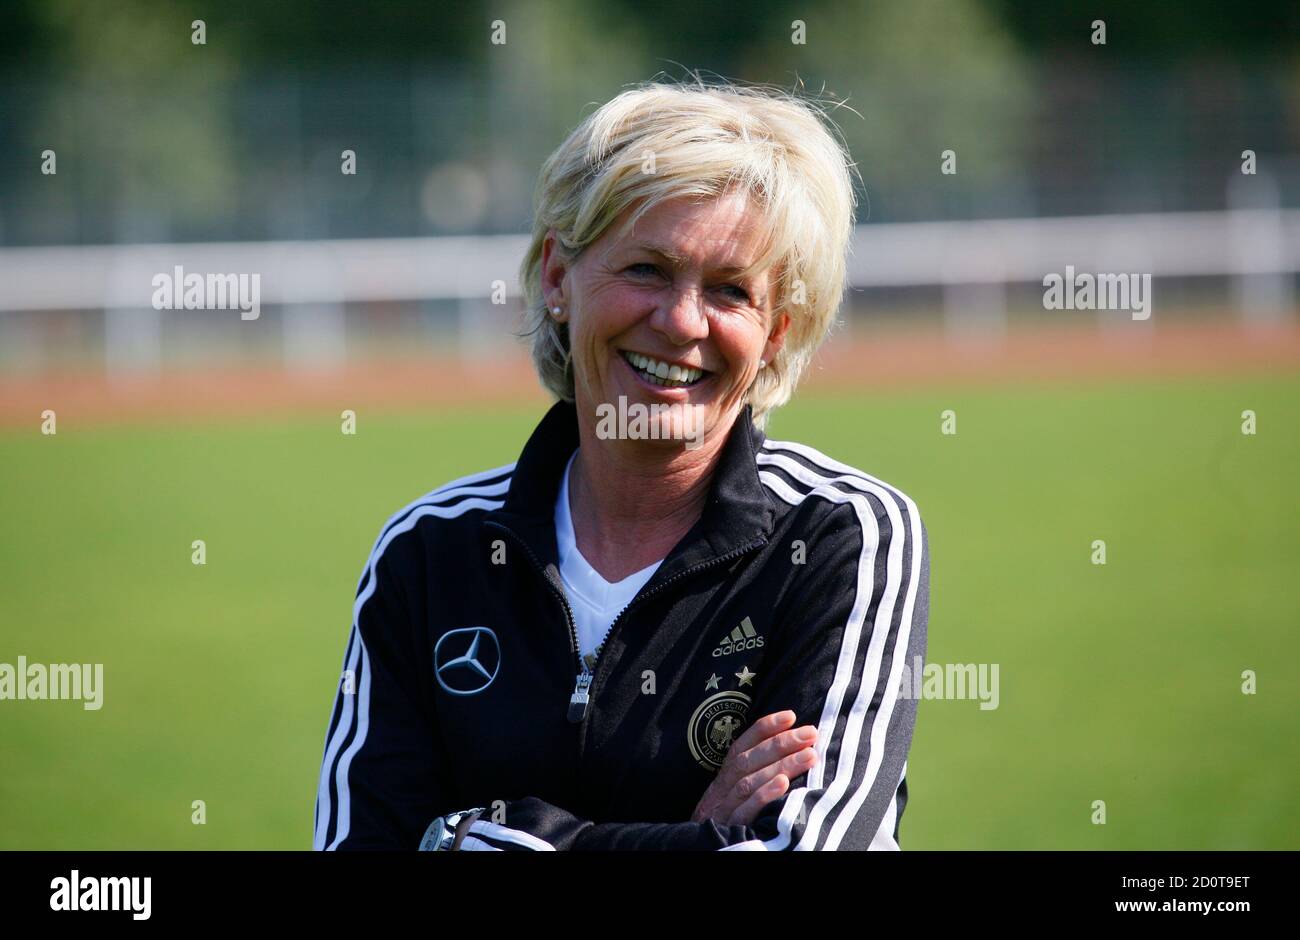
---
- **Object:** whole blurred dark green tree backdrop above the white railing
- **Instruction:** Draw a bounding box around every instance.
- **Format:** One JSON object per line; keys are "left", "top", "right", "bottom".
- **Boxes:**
{"left": 0, "top": 0, "right": 1300, "bottom": 242}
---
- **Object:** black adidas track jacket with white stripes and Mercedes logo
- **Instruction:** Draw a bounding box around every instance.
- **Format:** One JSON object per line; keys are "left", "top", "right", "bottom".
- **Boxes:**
{"left": 315, "top": 402, "right": 930, "bottom": 852}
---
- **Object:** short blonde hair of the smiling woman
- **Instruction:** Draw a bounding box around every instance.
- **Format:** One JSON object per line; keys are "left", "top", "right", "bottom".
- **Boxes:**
{"left": 520, "top": 77, "right": 857, "bottom": 428}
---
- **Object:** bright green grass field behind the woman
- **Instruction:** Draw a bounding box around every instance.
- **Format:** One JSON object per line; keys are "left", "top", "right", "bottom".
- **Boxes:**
{"left": 0, "top": 377, "right": 1300, "bottom": 849}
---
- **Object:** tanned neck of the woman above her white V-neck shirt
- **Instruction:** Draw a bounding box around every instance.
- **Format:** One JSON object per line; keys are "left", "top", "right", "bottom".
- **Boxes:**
{"left": 569, "top": 410, "right": 727, "bottom": 581}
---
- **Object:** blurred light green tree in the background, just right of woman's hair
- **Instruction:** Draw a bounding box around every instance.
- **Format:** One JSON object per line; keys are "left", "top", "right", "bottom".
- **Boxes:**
{"left": 750, "top": 0, "right": 1032, "bottom": 221}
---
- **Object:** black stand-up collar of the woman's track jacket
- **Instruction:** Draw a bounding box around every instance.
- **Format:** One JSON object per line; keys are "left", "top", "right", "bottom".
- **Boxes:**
{"left": 484, "top": 400, "right": 775, "bottom": 584}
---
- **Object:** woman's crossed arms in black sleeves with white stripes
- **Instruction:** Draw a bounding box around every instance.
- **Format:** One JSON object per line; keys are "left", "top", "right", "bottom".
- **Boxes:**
{"left": 315, "top": 510, "right": 930, "bottom": 852}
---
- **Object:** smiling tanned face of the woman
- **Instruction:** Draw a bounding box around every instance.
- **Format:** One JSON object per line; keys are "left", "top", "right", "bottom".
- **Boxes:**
{"left": 542, "top": 192, "right": 789, "bottom": 447}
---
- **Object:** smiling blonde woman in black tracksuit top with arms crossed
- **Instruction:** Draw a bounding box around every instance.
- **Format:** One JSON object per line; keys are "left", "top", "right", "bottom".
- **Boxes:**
{"left": 316, "top": 83, "right": 928, "bottom": 850}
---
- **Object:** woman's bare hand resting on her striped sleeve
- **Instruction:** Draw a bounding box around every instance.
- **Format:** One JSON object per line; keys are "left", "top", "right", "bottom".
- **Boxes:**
{"left": 690, "top": 711, "right": 816, "bottom": 826}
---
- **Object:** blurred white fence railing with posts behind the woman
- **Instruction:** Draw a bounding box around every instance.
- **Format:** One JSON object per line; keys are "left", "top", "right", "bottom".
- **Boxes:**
{"left": 0, "top": 208, "right": 1300, "bottom": 361}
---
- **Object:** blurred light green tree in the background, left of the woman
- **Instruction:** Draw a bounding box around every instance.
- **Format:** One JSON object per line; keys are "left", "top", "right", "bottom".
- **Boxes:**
{"left": 20, "top": 0, "right": 237, "bottom": 239}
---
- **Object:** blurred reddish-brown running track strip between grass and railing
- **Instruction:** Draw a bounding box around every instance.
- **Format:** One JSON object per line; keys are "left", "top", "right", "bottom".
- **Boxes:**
{"left": 0, "top": 321, "right": 1300, "bottom": 428}
